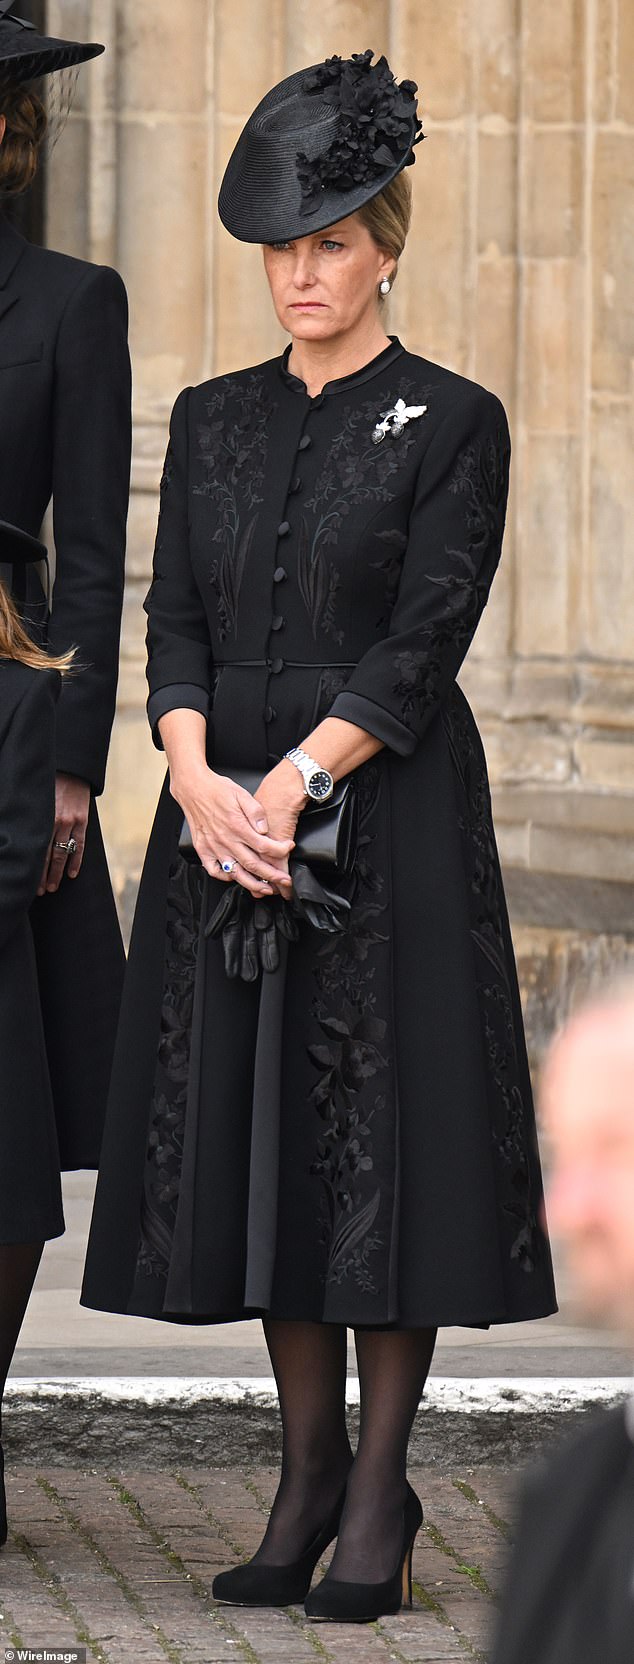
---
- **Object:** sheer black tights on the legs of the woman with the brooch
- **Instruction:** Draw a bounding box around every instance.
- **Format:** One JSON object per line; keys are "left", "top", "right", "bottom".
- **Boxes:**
{"left": 255, "top": 1320, "right": 436, "bottom": 1582}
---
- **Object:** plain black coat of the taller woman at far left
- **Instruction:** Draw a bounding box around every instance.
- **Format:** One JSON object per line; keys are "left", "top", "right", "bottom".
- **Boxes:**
{"left": 0, "top": 215, "right": 131, "bottom": 1168}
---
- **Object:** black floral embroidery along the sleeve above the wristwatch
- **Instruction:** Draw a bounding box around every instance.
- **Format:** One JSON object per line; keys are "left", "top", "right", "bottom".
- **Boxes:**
{"left": 393, "top": 419, "right": 509, "bottom": 726}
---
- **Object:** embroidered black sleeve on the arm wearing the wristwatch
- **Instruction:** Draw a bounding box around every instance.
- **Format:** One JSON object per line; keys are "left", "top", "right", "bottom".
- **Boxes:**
{"left": 328, "top": 386, "right": 511, "bottom": 755}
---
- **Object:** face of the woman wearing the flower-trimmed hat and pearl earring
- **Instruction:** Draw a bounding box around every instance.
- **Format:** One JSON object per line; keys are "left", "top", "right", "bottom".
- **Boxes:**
{"left": 263, "top": 213, "right": 394, "bottom": 341}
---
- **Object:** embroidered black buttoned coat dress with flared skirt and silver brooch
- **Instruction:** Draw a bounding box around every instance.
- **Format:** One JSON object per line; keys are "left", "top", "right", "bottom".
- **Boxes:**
{"left": 82, "top": 339, "right": 554, "bottom": 1326}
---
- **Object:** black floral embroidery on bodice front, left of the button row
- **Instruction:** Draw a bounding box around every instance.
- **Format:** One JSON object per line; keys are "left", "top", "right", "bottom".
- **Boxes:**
{"left": 193, "top": 374, "right": 276, "bottom": 642}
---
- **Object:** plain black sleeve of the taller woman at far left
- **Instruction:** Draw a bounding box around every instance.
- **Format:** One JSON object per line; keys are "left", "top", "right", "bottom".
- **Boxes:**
{"left": 48, "top": 266, "right": 131, "bottom": 792}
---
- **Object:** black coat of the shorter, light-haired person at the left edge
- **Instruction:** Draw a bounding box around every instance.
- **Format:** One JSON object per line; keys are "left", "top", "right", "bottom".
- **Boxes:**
{"left": 0, "top": 659, "right": 63, "bottom": 1243}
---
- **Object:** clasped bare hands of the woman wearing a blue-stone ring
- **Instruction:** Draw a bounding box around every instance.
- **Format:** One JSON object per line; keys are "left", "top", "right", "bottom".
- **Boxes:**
{"left": 171, "top": 760, "right": 305, "bottom": 899}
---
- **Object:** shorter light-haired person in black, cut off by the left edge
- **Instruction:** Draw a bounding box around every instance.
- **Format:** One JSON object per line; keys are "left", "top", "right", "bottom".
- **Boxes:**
{"left": 0, "top": 522, "right": 68, "bottom": 1544}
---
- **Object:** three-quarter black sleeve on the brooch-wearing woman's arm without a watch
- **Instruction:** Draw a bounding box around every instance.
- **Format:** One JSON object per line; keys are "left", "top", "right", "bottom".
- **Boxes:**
{"left": 145, "top": 388, "right": 211, "bottom": 749}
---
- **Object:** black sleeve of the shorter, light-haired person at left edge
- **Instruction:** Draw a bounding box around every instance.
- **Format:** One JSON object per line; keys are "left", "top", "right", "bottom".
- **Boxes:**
{"left": 0, "top": 671, "right": 60, "bottom": 948}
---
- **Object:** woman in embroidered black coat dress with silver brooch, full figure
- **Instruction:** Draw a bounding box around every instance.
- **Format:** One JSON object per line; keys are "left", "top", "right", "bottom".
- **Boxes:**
{"left": 82, "top": 53, "right": 554, "bottom": 1619}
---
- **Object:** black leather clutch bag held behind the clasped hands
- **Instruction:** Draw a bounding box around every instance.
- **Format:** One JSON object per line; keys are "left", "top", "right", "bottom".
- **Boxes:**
{"left": 178, "top": 769, "right": 358, "bottom": 877}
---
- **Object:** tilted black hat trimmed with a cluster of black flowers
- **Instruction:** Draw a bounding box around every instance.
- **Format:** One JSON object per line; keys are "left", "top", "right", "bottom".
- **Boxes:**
{"left": 218, "top": 50, "right": 424, "bottom": 243}
